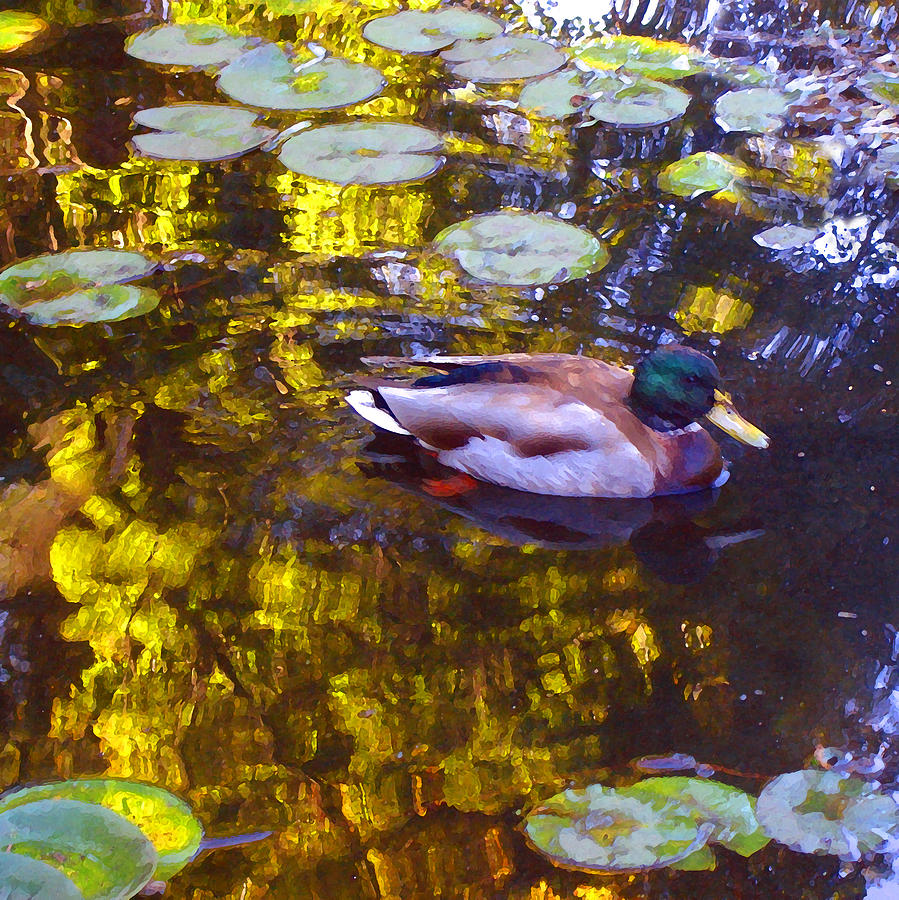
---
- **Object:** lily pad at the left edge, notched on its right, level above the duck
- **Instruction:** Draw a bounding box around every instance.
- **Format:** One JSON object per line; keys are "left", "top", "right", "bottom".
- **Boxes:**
{"left": 0, "top": 249, "right": 161, "bottom": 326}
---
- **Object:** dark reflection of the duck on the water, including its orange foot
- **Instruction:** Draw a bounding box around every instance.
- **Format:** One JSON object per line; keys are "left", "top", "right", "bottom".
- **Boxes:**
{"left": 359, "top": 432, "right": 764, "bottom": 584}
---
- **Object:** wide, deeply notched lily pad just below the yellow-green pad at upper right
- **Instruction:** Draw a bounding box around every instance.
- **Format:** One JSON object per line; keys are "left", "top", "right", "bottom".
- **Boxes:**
{"left": 518, "top": 69, "right": 690, "bottom": 128}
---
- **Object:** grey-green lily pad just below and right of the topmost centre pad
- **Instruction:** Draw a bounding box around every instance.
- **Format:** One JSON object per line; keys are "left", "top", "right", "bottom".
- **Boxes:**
{"left": 440, "top": 35, "right": 567, "bottom": 84}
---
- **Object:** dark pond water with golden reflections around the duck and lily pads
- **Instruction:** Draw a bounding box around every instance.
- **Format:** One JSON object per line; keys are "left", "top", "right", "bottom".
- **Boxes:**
{"left": 0, "top": 0, "right": 899, "bottom": 900}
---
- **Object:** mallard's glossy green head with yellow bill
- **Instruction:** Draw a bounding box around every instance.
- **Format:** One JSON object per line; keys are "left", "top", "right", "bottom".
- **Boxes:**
{"left": 629, "top": 346, "right": 768, "bottom": 447}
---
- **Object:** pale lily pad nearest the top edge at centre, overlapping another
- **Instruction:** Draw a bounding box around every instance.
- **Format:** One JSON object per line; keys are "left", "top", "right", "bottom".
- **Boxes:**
{"left": 362, "top": 7, "right": 503, "bottom": 53}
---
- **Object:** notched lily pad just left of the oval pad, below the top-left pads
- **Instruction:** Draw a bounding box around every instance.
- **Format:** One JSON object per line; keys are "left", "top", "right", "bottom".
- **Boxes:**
{"left": 132, "top": 103, "right": 277, "bottom": 162}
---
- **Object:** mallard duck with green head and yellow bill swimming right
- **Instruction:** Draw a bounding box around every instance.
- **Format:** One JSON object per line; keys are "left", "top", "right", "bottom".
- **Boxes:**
{"left": 347, "top": 346, "right": 769, "bottom": 497}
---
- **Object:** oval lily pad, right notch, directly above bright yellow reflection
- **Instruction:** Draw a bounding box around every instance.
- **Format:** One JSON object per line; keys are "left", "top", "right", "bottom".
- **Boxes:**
{"left": 278, "top": 122, "right": 444, "bottom": 184}
